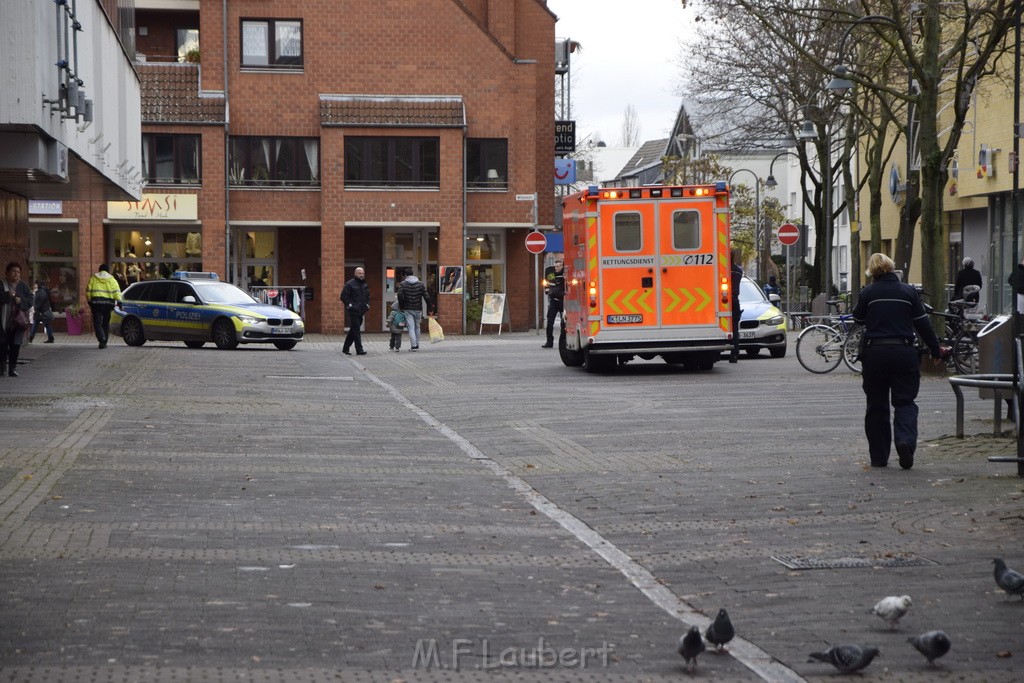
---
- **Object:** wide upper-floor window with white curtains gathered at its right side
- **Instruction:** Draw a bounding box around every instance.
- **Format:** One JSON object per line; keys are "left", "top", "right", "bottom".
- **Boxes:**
{"left": 227, "top": 136, "right": 319, "bottom": 186}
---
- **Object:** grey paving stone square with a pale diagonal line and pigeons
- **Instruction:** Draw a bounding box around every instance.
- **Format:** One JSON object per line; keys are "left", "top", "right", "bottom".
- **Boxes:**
{"left": 0, "top": 334, "right": 1024, "bottom": 682}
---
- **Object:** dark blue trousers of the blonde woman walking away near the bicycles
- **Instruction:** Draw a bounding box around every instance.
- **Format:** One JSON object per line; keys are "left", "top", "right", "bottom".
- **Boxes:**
{"left": 861, "top": 346, "right": 921, "bottom": 465}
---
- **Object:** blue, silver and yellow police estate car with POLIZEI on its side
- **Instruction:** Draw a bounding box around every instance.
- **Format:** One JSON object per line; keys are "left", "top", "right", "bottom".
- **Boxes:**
{"left": 111, "top": 270, "right": 305, "bottom": 350}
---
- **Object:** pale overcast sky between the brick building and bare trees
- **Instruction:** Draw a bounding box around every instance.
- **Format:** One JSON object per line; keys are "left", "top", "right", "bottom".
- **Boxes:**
{"left": 548, "top": 0, "right": 693, "bottom": 145}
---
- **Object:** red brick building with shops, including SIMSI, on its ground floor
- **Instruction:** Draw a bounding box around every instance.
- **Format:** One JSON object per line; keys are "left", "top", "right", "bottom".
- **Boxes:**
{"left": 33, "top": 0, "right": 556, "bottom": 334}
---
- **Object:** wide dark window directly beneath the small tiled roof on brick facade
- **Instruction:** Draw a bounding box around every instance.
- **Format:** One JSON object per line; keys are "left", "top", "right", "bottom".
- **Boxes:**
{"left": 345, "top": 137, "right": 440, "bottom": 187}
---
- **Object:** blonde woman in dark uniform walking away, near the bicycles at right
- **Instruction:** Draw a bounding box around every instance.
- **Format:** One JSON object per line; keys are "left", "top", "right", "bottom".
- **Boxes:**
{"left": 853, "top": 254, "right": 942, "bottom": 470}
